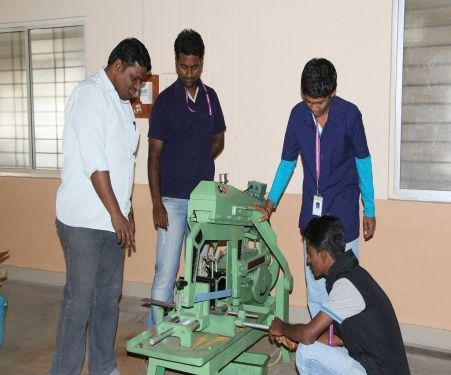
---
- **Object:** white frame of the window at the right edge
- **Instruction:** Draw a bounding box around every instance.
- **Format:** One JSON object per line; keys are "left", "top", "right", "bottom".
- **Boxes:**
{"left": 389, "top": 0, "right": 451, "bottom": 203}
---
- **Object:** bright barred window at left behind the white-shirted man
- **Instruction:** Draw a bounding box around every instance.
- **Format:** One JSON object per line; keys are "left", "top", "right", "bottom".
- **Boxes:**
{"left": 0, "top": 25, "right": 85, "bottom": 171}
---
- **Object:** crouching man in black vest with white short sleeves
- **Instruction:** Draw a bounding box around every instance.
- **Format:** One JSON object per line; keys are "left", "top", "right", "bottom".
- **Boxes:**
{"left": 269, "top": 216, "right": 410, "bottom": 375}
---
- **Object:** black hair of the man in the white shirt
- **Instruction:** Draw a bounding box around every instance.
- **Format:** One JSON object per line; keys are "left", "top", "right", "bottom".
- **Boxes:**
{"left": 108, "top": 38, "right": 152, "bottom": 71}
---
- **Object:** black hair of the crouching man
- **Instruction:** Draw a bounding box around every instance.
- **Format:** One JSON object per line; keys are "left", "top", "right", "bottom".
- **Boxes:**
{"left": 302, "top": 216, "right": 346, "bottom": 260}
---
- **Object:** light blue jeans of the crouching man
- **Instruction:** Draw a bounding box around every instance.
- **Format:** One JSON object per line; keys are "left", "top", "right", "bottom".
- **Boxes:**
{"left": 296, "top": 341, "right": 366, "bottom": 375}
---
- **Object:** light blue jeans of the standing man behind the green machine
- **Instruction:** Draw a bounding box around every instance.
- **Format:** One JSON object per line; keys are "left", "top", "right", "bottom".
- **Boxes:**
{"left": 147, "top": 197, "right": 188, "bottom": 328}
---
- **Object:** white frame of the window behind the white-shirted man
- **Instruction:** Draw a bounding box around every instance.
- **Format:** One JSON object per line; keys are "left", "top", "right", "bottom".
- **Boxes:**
{"left": 0, "top": 17, "right": 87, "bottom": 178}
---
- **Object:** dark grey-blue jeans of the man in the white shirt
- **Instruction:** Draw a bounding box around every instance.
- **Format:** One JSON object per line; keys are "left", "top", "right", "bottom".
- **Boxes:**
{"left": 51, "top": 220, "right": 124, "bottom": 375}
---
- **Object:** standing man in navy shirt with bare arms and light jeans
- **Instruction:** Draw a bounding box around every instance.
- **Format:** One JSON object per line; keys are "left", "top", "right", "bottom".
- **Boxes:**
{"left": 147, "top": 29, "right": 226, "bottom": 327}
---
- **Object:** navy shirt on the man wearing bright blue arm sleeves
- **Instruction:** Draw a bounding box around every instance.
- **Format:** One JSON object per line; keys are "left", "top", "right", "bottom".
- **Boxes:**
{"left": 282, "top": 96, "right": 370, "bottom": 242}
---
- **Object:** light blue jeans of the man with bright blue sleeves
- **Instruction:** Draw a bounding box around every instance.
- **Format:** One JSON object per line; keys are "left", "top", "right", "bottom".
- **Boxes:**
{"left": 304, "top": 238, "right": 359, "bottom": 319}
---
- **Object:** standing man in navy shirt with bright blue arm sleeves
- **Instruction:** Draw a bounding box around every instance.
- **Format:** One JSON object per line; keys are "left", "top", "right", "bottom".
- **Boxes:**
{"left": 256, "top": 58, "right": 376, "bottom": 317}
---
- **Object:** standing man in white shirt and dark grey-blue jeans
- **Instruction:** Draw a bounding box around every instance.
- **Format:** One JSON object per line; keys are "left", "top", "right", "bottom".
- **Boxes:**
{"left": 51, "top": 38, "right": 151, "bottom": 375}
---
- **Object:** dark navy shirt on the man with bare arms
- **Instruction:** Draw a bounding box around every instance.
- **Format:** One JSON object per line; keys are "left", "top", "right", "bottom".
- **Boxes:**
{"left": 148, "top": 80, "right": 226, "bottom": 199}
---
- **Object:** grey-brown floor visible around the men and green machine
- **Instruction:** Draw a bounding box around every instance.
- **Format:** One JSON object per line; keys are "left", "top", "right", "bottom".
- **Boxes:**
{"left": 0, "top": 280, "right": 451, "bottom": 375}
